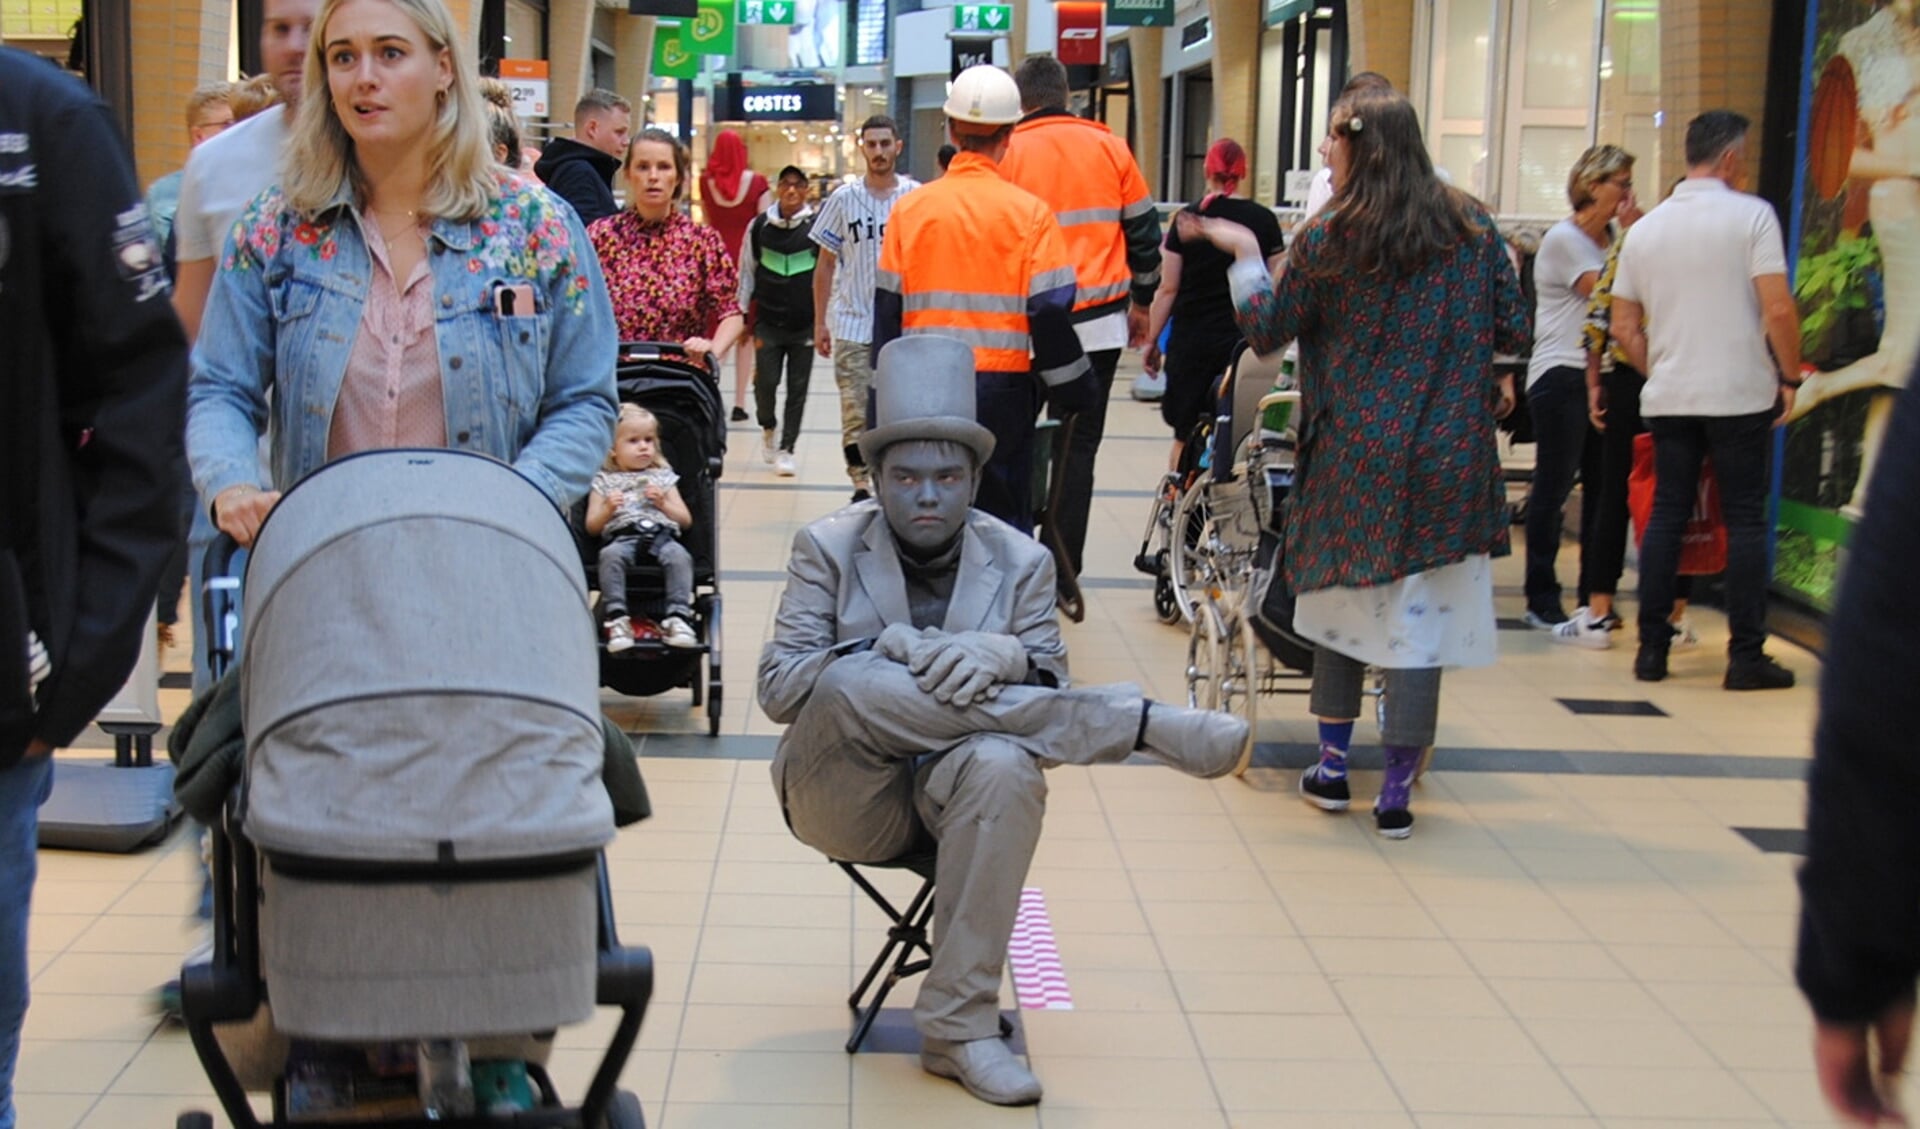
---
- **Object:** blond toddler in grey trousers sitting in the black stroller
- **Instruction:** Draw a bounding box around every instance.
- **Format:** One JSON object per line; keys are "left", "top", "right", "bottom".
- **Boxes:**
{"left": 586, "top": 403, "right": 701, "bottom": 655}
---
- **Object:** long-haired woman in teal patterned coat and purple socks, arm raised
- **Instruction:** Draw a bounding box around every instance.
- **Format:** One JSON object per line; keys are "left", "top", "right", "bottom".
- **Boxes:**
{"left": 1179, "top": 90, "right": 1528, "bottom": 839}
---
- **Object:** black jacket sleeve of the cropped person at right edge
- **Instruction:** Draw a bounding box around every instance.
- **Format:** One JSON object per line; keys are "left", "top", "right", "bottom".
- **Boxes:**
{"left": 1793, "top": 360, "right": 1920, "bottom": 1023}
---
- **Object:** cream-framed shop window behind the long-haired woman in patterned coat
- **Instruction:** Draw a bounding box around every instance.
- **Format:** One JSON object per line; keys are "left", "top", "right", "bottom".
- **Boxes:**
{"left": 1417, "top": 0, "right": 1659, "bottom": 215}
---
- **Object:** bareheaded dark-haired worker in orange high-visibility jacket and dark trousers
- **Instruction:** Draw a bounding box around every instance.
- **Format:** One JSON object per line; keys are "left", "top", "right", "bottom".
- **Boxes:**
{"left": 1000, "top": 56, "right": 1160, "bottom": 588}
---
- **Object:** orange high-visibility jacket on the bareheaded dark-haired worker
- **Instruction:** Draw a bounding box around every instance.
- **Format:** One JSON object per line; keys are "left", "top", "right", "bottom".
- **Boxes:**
{"left": 1000, "top": 109, "right": 1160, "bottom": 321}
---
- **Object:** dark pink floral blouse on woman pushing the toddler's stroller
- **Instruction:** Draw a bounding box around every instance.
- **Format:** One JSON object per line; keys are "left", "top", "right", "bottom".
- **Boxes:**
{"left": 588, "top": 211, "right": 739, "bottom": 342}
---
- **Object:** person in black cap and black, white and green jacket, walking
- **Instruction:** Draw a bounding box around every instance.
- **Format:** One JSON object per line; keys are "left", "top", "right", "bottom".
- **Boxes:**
{"left": 739, "top": 165, "right": 820, "bottom": 478}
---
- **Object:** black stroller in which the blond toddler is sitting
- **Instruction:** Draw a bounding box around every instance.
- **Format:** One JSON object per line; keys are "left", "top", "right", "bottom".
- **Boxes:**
{"left": 574, "top": 342, "right": 726, "bottom": 735}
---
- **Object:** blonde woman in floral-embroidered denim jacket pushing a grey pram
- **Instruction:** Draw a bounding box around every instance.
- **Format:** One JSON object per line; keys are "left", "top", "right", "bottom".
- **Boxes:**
{"left": 188, "top": 0, "right": 616, "bottom": 545}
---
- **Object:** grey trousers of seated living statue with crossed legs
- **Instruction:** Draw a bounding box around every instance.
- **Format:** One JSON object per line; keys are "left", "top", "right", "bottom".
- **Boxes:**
{"left": 774, "top": 653, "right": 1140, "bottom": 1041}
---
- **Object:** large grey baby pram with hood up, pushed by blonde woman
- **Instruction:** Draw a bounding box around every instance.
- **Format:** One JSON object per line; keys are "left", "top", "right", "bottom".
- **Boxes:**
{"left": 180, "top": 451, "right": 653, "bottom": 1129}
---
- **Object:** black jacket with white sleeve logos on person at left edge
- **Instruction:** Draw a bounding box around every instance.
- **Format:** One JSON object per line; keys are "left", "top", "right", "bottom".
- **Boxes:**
{"left": 0, "top": 48, "right": 186, "bottom": 768}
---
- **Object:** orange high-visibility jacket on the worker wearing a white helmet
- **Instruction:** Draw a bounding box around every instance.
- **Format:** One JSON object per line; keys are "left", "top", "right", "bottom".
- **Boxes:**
{"left": 874, "top": 154, "right": 1091, "bottom": 388}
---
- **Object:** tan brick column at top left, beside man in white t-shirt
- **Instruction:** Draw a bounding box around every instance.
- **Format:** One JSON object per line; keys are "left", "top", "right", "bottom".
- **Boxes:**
{"left": 129, "top": 0, "right": 232, "bottom": 186}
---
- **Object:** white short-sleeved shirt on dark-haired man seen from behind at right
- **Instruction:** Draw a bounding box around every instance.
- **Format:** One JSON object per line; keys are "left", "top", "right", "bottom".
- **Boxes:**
{"left": 1613, "top": 177, "right": 1788, "bottom": 417}
